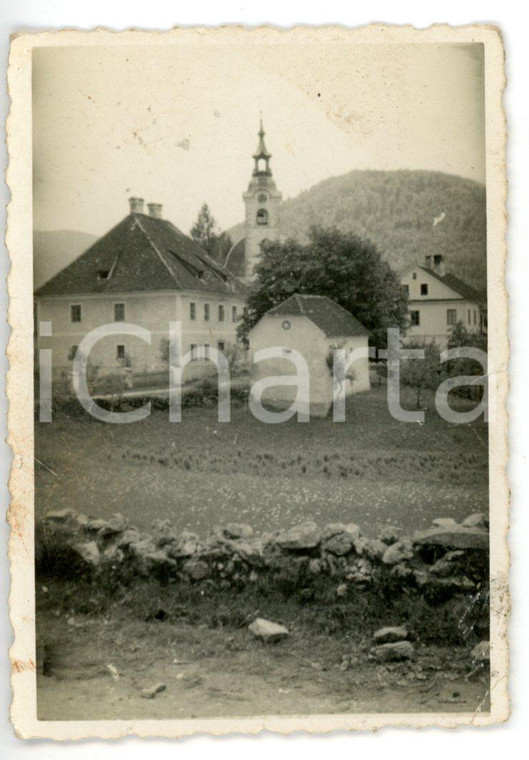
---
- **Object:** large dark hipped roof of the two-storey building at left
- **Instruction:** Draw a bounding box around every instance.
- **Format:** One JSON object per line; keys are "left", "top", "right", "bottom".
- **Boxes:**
{"left": 36, "top": 213, "right": 246, "bottom": 296}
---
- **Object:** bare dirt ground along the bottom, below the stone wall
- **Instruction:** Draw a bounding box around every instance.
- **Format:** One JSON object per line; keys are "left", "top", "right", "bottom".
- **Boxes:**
{"left": 37, "top": 588, "right": 489, "bottom": 720}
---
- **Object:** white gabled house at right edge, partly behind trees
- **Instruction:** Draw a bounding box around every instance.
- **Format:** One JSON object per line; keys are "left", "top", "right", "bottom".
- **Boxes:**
{"left": 400, "top": 254, "right": 485, "bottom": 348}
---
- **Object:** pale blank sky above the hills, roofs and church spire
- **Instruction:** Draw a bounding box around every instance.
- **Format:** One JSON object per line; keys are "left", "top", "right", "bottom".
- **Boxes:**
{"left": 33, "top": 42, "right": 485, "bottom": 235}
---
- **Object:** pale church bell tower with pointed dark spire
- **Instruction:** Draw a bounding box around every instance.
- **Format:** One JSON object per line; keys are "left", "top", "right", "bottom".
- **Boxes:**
{"left": 242, "top": 119, "right": 282, "bottom": 281}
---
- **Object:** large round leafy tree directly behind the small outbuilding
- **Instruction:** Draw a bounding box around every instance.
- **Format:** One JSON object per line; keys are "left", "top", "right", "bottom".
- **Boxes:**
{"left": 239, "top": 227, "right": 408, "bottom": 346}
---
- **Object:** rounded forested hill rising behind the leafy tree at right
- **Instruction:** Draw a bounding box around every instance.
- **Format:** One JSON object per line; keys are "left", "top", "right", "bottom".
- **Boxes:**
{"left": 228, "top": 171, "right": 486, "bottom": 289}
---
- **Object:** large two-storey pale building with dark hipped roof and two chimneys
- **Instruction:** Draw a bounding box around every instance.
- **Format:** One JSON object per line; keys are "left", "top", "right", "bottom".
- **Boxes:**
{"left": 35, "top": 198, "right": 245, "bottom": 376}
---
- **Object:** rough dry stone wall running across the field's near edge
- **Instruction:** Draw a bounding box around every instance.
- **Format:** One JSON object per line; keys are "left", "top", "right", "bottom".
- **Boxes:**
{"left": 36, "top": 509, "right": 489, "bottom": 601}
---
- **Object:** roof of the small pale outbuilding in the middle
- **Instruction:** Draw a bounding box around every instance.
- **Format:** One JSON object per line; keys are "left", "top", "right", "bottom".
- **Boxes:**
{"left": 265, "top": 293, "right": 370, "bottom": 338}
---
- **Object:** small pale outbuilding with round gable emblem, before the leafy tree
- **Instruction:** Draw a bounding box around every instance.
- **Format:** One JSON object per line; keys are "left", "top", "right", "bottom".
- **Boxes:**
{"left": 248, "top": 293, "right": 370, "bottom": 417}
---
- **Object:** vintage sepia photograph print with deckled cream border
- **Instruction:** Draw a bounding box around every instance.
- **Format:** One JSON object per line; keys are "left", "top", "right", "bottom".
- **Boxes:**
{"left": 8, "top": 27, "right": 507, "bottom": 736}
